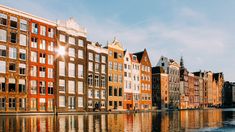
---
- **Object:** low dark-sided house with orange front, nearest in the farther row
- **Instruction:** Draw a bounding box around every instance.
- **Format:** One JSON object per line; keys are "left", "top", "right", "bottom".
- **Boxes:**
{"left": 152, "top": 66, "right": 169, "bottom": 109}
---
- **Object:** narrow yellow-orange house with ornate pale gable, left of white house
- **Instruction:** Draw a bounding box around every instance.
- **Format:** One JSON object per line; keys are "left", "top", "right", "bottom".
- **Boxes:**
{"left": 105, "top": 38, "right": 124, "bottom": 110}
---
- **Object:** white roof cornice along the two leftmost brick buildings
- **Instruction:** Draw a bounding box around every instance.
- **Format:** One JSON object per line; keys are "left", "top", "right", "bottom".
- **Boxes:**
{"left": 0, "top": 4, "right": 56, "bottom": 26}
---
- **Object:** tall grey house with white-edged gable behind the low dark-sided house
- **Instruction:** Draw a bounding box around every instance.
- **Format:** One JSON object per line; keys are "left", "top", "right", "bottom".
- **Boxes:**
{"left": 157, "top": 56, "right": 180, "bottom": 108}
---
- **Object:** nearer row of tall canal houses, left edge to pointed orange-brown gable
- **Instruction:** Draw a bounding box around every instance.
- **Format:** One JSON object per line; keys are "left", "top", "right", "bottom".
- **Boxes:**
{"left": 0, "top": 5, "right": 152, "bottom": 112}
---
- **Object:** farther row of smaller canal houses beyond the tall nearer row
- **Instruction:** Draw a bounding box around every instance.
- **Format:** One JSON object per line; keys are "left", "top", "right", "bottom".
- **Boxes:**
{"left": 152, "top": 56, "right": 224, "bottom": 109}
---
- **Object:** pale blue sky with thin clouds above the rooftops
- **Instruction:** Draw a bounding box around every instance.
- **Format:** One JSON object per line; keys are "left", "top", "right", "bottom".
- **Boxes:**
{"left": 0, "top": 0, "right": 235, "bottom": 81}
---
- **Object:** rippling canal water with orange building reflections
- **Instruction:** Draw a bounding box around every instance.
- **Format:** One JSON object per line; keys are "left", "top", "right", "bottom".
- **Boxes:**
{"left": 0, "top": 109, "right": 235, "bottom": 132}
